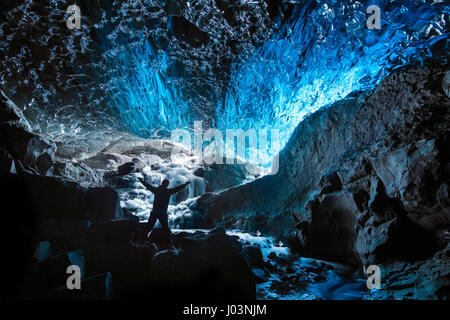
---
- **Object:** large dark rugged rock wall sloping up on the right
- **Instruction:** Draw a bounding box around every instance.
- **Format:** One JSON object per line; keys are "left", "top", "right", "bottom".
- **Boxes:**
{"left": 197, "top": 63, "right": 450, "bottom": 298}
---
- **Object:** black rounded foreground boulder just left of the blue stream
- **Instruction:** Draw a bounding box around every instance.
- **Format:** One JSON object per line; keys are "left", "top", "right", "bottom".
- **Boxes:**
{"left": 171, "top": 233, "right": 256, "bottom": 300}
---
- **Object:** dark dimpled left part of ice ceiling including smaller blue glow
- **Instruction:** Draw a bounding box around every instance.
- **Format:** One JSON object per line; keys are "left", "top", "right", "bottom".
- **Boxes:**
{"left": 0, "top": 0, "right": 271, "bottom": 158}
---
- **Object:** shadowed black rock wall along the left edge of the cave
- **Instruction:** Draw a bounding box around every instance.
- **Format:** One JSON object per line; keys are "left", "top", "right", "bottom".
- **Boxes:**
{"left": 0, "top": 92, "right": 124, "bottom": 299}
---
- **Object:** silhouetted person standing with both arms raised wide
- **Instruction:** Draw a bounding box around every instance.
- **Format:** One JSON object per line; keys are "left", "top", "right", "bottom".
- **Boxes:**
{"left": 139, "top": 179, "right": 190, "bottom": 240}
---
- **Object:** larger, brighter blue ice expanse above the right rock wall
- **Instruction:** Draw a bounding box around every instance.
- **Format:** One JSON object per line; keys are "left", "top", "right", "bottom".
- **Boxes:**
{"left": 217, "top": 0, "right": 450, "bottom": 152}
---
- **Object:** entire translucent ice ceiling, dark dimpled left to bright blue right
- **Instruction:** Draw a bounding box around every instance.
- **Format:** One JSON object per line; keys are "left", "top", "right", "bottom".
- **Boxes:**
{"left": 0, "top": 0, "right": 450, "bottom": 159}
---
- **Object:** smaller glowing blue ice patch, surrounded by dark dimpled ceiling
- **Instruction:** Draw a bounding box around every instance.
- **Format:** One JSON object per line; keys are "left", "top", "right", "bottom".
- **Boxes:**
{"left": 103, "top": 41, "right": 194, "bottom": 137}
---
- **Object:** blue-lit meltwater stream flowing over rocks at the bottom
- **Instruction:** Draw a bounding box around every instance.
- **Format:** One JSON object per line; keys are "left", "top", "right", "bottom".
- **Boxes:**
{"left": 173, "top": 229, "right": 368, "bottom": 300}
